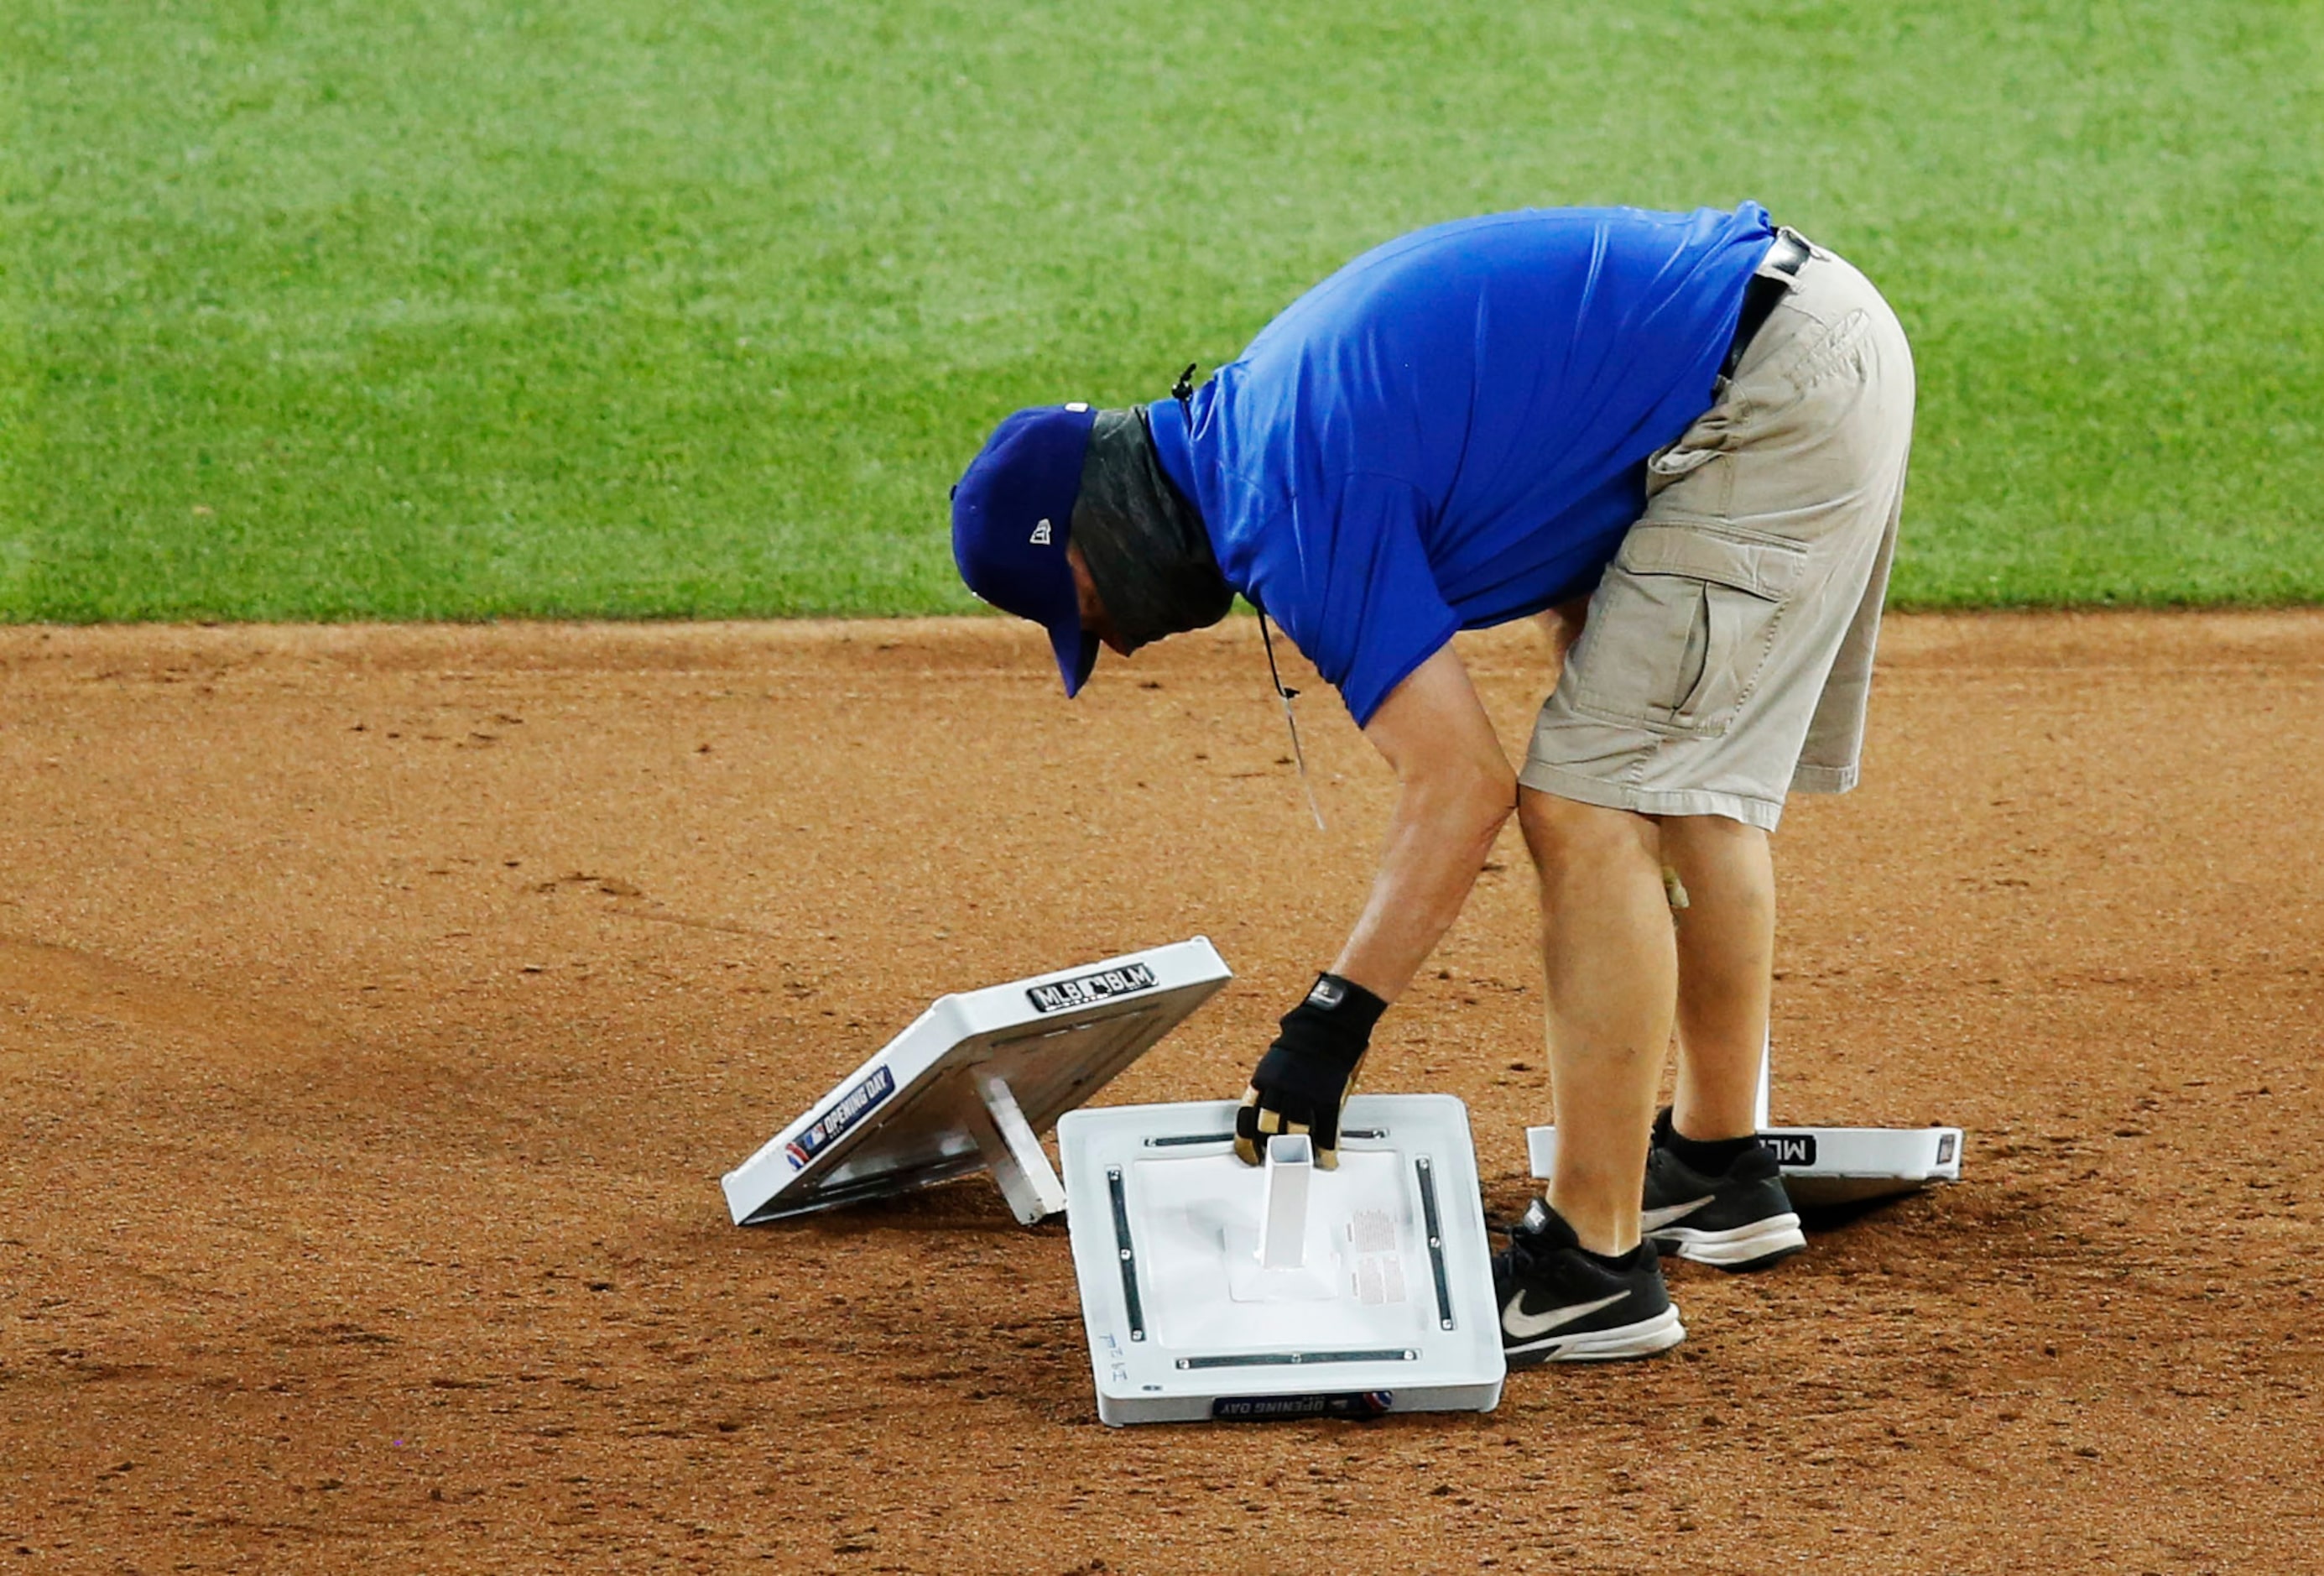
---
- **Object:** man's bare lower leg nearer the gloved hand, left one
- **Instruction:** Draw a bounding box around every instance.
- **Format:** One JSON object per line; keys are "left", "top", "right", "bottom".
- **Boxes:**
{"left": 1518, "top": 788, "right": 1678, "bottom": 1255}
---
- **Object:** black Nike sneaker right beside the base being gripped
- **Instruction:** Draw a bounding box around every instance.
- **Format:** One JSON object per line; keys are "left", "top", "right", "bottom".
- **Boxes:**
{"left": 1492, "top": 1199, "right": 1687, "bottom": 1369}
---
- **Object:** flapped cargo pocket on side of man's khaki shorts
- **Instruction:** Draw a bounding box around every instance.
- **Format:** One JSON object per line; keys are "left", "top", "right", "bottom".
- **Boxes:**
{"left": 1569, "top": 525, "right": 1808, "bottom": 737}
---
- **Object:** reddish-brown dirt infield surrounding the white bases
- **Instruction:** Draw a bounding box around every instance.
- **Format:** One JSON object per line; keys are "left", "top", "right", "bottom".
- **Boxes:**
{"left": 0, "top": 613, "right": 2324, "bottom": 1573}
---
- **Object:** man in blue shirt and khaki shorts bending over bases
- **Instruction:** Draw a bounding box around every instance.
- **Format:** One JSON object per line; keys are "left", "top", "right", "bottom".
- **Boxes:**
{"left": 953, "top": 202, "right": 1913, "bottom": 1365}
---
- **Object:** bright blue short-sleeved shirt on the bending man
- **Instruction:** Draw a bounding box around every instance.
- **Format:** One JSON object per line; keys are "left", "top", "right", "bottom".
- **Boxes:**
{"left": 1153, "top": 202, "right": 1774, "bottom": 725}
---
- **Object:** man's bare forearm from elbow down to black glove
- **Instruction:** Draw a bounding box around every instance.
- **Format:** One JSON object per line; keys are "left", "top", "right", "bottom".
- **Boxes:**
{"left": 1331, "top": 774, "right": 1518, "bottom": 1002}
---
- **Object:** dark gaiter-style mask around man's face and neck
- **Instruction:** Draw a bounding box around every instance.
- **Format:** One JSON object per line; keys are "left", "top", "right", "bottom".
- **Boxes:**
{"left": 1069, "top": 410, "right": 1234, "bottom": 651}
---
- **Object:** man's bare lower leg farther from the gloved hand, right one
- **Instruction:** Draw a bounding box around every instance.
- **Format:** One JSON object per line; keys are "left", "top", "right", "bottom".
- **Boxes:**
{"left": 1664, "top": 816, "right": 1775, "bottom": 1144}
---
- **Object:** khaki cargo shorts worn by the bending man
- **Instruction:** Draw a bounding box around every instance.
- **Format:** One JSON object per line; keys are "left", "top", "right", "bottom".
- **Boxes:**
{"left": 1518, "top": 234, "right": 1913, "bottom": 830}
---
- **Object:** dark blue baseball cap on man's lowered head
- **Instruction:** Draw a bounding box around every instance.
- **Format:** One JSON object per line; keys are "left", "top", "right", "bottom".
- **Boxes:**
{"left": 953, "top": 399, "right": 1097, "bottom": 695}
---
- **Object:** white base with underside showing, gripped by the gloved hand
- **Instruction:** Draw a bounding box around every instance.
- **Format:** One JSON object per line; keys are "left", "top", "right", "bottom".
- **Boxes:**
{"left": 1057, "top": 1095, "right": 1506, "bottom": 1425}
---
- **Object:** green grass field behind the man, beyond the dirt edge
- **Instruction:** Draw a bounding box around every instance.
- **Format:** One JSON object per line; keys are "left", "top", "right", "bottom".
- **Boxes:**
{"left": 0, "top": 0, "right": 2324, "bottom": 621}
